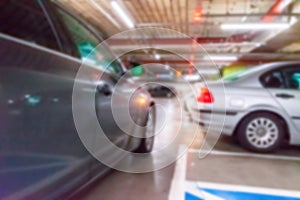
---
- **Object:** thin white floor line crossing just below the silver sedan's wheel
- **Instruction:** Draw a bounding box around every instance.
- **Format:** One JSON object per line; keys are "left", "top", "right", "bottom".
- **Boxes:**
{"left": 188, "top": 149, "right": 300, "bottom": 161}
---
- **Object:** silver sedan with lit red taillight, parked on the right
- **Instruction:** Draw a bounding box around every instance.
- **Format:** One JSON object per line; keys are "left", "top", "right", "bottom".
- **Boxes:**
{"left": 192, "top": 62, "right": 300, "bottom": 152}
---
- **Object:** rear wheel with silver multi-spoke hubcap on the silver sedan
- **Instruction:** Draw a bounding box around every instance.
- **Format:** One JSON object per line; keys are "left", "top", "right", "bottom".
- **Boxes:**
{"left": 237, "top": 113, "right": 284, "bottom": 153}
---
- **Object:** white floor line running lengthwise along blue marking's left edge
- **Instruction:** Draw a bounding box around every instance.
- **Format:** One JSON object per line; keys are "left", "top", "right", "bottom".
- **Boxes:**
{"left": 168, "top": 145, "right": 187, "bottom": 200}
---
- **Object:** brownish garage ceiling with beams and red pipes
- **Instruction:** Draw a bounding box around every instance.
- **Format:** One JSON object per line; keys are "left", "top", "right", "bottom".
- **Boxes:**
{"left": 60, "top": 0, "right": 300, "bottom": 68}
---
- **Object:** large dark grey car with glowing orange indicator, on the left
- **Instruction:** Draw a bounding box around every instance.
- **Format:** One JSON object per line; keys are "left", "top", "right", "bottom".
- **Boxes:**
{"left": 0, "top": 0, "right": 155, "bottom": 200}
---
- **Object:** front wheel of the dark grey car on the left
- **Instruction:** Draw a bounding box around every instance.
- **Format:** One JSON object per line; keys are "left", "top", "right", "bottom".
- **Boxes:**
{"left": 135, "top": 105, "right": 156, "bottom": 153}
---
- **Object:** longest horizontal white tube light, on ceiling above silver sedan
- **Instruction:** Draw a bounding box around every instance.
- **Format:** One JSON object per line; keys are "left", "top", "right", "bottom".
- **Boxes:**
{"left": 221, "top": 23, "right": 291, "bottom": 30}
